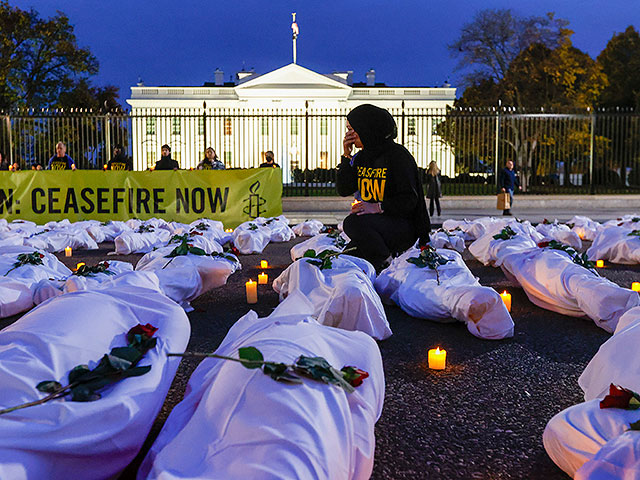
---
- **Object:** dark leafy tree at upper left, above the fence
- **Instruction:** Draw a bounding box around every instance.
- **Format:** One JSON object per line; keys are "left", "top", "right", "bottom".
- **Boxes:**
{"left": 0, "top": 0, "right": 113, "bottom": 109}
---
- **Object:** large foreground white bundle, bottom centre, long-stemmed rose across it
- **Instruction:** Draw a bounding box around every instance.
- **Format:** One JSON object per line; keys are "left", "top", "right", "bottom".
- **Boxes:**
{"left": 137, "top": 298, "right": 384, "bottom": 480}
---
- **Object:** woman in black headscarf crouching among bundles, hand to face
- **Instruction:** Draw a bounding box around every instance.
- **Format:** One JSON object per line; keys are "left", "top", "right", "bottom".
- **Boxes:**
{"left": 336, "top": 104, "right": 431, "bottom": 272}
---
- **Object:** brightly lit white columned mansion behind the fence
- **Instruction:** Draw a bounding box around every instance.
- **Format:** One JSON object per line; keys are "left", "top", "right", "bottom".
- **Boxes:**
{"left": 127, "top": 63, "right": 456, "bottom": 182}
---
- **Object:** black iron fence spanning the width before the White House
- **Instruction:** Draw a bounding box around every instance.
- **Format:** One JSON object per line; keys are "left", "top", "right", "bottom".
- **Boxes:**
{"left": 0, "top": 105, "right": 640, "bottom": 195}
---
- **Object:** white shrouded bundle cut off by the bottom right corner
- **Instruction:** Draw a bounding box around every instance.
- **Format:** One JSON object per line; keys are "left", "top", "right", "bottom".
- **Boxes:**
{"left": 543, "top": 307, "right": 640, "bottom": 479}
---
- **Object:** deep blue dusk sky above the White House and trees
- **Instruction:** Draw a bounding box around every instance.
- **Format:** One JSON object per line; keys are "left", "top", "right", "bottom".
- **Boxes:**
{"left": 10, "top": 0, "right": 640, "bottom": 103}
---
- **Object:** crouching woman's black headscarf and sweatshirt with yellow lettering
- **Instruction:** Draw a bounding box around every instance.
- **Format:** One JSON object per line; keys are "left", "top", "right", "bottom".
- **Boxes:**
{"left": 336, "top": 104, "right": 431, "bottom": 244}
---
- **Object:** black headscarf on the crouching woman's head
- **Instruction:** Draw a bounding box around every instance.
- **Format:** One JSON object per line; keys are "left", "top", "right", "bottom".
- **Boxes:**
{"left": 347, "top": 103, "right": 398, "bottom": 155}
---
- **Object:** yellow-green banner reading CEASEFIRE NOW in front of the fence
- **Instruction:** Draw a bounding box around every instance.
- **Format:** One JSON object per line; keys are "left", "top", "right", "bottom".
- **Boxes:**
{"left": 0, "top": 168, "right": 282, "bottom": 228}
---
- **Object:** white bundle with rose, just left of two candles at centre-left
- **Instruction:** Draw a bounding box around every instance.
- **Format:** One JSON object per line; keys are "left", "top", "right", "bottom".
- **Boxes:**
{"left": 136, "top": 245, "right": 241, "bottom": 304}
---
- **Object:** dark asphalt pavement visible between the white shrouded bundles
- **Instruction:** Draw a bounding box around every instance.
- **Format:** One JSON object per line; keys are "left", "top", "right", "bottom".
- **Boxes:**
{"left": 5, "top": 231, "right": 640, "bottom": 480}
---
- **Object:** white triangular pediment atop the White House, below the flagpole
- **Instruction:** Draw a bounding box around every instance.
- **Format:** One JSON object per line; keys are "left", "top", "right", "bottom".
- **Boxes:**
{"left": 235, "top": 63, "right": 351, "bottom": 99}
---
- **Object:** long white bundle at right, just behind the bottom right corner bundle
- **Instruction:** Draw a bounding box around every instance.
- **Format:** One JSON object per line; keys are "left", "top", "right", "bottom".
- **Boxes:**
{"left": 501, "top": 248, "right": 640, "bottom": 332}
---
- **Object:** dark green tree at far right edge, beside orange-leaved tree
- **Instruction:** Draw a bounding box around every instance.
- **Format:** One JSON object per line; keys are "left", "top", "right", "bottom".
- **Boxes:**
{"left": 597, "top": 26, "right": 640, "bottom": 110}
